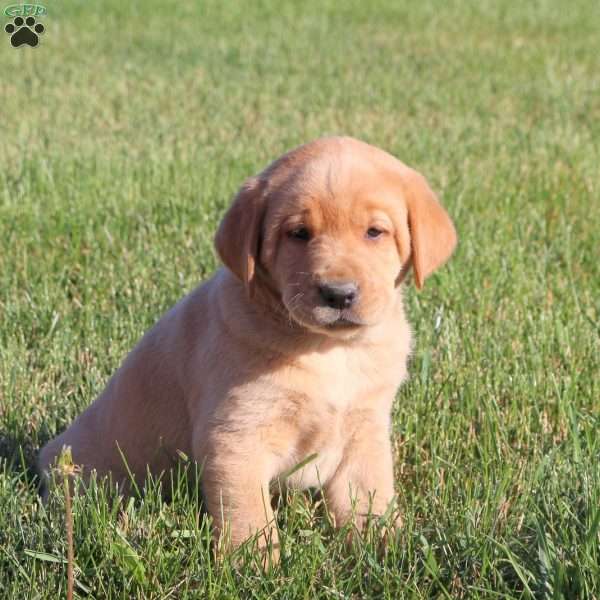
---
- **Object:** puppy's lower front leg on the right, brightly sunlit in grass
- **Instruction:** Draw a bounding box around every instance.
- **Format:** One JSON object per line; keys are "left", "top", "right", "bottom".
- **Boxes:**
{"left": 324, "top": 420, "right": 394, "bottom": 531}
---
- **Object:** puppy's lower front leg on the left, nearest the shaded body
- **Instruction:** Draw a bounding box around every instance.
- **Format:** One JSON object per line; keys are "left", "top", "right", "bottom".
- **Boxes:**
{"left": 202, "top": 446, "right": 279, "bottom": 558}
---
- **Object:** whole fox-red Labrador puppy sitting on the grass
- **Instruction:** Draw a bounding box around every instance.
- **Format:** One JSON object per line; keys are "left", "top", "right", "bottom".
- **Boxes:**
{"left": 39, "top": 137, "right": 456, "bottom": 546}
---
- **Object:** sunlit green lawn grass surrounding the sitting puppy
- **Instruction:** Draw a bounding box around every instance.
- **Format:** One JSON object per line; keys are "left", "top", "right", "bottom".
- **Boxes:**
{"left": 0, "top": 0, "right": 600, "bottom": 599}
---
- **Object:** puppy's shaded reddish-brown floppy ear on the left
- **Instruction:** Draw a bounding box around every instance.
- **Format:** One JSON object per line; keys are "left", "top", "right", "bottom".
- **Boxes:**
{"left": 215, "top": 177, "right": 265, "bottom": 295}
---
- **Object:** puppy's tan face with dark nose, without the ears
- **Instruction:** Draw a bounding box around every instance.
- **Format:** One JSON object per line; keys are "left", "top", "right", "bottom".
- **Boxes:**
{"left": 260, "top": 157, "right": 405, "bottom": 337}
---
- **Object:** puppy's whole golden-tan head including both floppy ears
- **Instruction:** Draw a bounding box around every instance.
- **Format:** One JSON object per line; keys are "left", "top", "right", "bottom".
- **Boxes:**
{"left": 216, "top": 138, "right": 456, "bottom": 337}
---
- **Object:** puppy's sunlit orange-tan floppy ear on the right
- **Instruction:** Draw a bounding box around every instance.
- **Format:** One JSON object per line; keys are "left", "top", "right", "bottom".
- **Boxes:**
{"left": 402, "top": 168, "right": 457, "bottom": 289}
